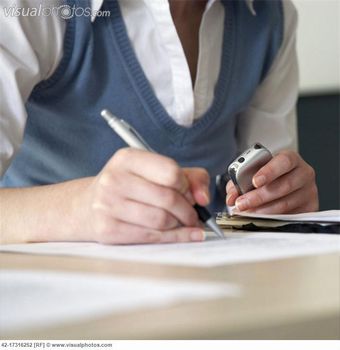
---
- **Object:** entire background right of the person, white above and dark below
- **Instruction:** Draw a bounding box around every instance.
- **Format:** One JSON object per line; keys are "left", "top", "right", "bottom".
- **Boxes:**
{"left": 293, "top": 0, "right": 340, "bottom": 210}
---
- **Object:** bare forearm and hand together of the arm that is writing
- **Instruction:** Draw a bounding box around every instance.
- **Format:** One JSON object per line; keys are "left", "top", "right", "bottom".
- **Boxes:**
{"left": 0, "top": 148, "right": 209, "bottom": 244}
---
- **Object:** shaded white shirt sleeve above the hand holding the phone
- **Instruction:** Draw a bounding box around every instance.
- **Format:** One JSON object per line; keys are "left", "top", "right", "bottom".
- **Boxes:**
{"left": 237, "top": 0, "right": 299, "bottom": 153}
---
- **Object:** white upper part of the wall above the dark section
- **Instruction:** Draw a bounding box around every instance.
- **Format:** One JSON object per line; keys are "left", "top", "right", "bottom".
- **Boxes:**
{"left": 293, "top": 0, "right": 340, "bottom": 94}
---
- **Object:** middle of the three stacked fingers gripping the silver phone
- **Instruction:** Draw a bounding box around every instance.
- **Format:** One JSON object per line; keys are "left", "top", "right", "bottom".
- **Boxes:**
{"left": 236, "top": 167, "right": 309, "bottom": 211}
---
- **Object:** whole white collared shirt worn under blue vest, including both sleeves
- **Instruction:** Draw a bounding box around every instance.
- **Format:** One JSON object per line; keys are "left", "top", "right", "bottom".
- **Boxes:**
{"left": 0, "top": 0, "right": 298, "bottom": 176}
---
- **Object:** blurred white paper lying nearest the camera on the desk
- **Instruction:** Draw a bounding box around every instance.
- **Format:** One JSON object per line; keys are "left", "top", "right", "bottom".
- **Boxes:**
{"left": 0, "top": 270, "right": 241, "bottom": 335}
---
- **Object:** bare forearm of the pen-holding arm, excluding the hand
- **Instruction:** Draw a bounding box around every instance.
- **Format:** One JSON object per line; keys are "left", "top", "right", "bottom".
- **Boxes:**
{"left": 0, "top": 178, "right": 92, "bottom": 244}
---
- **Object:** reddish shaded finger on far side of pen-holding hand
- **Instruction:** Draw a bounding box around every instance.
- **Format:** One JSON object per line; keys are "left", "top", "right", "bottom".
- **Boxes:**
{"left": 183, "top": 168, "right": 210, "bottom": 206}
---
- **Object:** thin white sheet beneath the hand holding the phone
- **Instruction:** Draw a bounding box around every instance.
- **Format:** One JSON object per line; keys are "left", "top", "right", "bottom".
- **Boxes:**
{"left": 235, "top": 210, "right": 340, "bottom": 223}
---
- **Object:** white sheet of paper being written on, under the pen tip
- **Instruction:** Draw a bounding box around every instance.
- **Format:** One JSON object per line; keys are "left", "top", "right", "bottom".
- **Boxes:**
{"left": 0, "top": 231, "right": 340, "bottom": 267}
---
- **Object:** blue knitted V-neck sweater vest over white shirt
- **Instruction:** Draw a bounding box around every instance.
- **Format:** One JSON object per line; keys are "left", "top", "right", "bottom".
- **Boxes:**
{"left": 0, "top": 0, "right": 283, "bottom": 210}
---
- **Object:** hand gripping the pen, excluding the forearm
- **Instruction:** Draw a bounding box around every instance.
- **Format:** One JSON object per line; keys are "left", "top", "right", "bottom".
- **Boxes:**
{"left": 83, "top": 148, "right": 209, "bottom": 244}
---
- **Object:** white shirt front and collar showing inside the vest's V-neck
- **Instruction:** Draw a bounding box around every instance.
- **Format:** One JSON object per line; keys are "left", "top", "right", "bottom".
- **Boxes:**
{"left": 119, "top": 0, "right": 224, "bottom": 126}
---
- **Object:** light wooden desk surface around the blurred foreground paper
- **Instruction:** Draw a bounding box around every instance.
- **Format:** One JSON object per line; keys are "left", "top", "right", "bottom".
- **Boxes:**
{"left": 0, "top": 253, "right": 340, "bottom": 339}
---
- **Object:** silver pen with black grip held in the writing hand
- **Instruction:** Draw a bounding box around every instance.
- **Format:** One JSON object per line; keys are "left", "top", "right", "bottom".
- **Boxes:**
{"left": 100, "top": 109, "right": 224, "bottom": 238}
